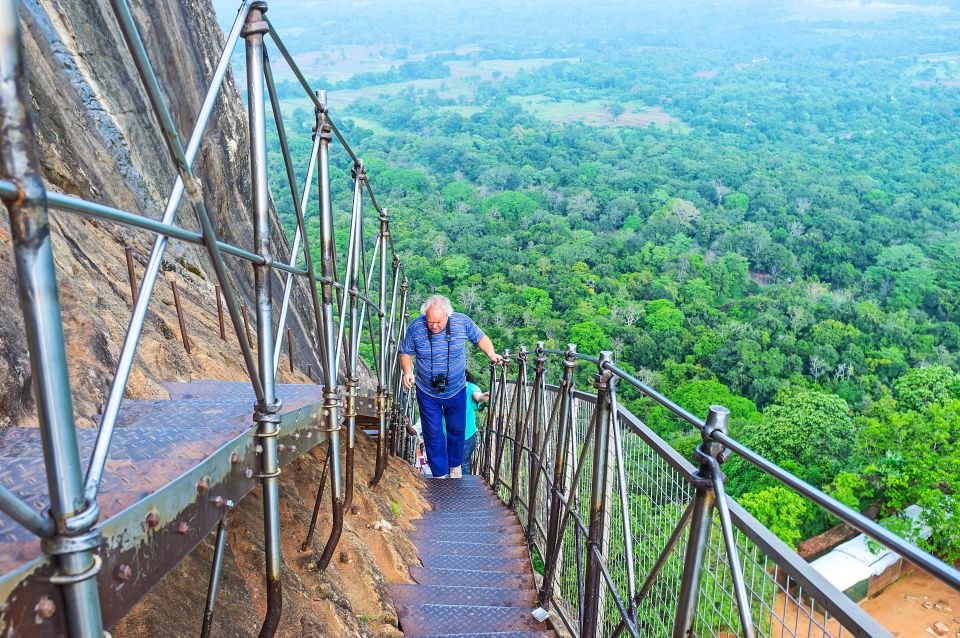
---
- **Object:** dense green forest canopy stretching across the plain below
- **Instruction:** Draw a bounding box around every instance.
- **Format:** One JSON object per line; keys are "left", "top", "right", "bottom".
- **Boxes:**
{"left": 221, "top": 2, "right": 960, "bottom": 560}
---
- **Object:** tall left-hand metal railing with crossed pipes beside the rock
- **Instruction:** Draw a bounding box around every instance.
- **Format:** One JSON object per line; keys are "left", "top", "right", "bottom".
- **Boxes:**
{"left": 0, "top": 0, "right": 412, "bottom": 638}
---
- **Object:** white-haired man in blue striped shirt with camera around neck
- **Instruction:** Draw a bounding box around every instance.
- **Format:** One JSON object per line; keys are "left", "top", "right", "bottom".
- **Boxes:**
{"left": 400, "top": 295, "right": 502, "bottom": 478}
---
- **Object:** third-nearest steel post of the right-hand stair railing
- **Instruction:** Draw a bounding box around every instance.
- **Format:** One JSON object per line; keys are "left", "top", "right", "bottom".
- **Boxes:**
{"left": 540, "top": 343, "right": 577, "bottom": 607}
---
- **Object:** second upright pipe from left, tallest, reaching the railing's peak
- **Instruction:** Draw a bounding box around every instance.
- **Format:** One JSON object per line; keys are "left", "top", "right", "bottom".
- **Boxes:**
{"left": 243, "top": 2, "right": 283, "bottom": 638}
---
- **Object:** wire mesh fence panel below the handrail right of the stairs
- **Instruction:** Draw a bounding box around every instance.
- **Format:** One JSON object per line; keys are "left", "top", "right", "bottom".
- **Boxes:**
{"left": 491, "top": 356, "right": 908, "bottom": 638}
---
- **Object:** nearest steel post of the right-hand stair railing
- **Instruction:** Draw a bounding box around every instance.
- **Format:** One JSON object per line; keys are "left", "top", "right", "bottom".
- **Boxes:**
{"left": 673, "top": 406, "right": 730, "bottom": 638}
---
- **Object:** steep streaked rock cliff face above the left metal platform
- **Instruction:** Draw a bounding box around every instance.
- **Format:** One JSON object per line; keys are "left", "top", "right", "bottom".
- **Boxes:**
{"left": 0, "top": 0, "right": 328, "bottom": 426}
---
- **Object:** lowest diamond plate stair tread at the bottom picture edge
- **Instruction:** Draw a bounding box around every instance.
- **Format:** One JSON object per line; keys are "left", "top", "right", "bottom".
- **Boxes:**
{"left": 397, "top": 604, "right": 547, "bottom": 636}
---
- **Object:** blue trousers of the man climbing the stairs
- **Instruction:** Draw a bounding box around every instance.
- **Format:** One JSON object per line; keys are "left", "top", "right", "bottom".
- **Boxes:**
{"left": 417, "top": 387, "right": 467, "bottom": 476}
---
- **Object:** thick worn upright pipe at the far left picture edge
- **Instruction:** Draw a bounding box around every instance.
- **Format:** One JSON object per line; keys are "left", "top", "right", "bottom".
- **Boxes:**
{"left": 0, "top": 0, "right": 103, "bottom": 638}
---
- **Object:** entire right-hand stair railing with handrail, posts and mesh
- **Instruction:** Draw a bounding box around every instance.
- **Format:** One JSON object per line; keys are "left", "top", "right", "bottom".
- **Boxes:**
{"left": 475, "top": 343, "right": 960, "bottom": 638}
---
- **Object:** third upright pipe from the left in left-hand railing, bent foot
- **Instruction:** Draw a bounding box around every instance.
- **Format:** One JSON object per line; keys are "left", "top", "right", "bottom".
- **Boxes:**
{"left": 317, "top": 91, "right": 343, "bottom": 571}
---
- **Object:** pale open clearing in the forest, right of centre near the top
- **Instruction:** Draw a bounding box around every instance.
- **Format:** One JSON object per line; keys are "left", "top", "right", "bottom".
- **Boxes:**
{"left": 509, "top": 95, "right": 690, "bottom": 133}
